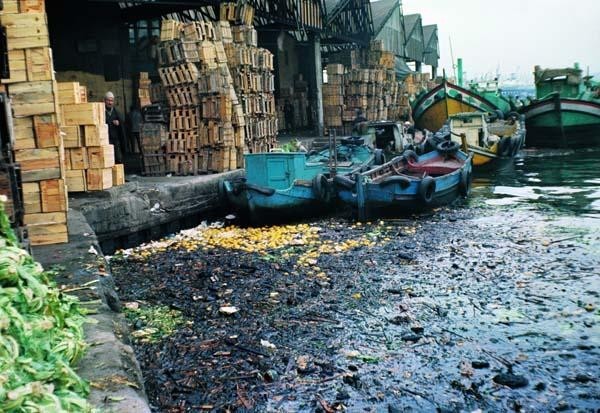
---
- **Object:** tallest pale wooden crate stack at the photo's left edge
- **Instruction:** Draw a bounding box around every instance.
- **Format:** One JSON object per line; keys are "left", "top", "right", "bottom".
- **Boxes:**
{"left": 0, "top": 0, "right": 68, "bottom": 245}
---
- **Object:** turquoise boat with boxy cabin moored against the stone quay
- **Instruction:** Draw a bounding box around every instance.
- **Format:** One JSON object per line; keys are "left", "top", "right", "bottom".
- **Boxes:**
{"left": 220, "top": 138, "right": 381, "bottom": 221}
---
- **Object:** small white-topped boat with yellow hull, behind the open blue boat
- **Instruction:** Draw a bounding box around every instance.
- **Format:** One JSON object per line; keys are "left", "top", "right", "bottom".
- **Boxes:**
{"left": 446, "top": 112, "right": 525, "bottom": 170}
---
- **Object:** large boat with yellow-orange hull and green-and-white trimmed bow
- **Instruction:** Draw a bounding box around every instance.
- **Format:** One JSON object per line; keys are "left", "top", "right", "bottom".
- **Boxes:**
{"left": 412, "top": 79, "right": 510, "bottom": 131}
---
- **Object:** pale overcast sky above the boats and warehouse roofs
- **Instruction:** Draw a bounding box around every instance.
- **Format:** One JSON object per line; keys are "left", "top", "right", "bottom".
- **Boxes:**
{"left": 402, "top": 0, "right": 600, "bottom": 83}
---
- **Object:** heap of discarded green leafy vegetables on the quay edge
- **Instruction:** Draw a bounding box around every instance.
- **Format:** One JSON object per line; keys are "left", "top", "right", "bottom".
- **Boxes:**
{"left": 0, "top": 202, "right": 93, "bottom": 413}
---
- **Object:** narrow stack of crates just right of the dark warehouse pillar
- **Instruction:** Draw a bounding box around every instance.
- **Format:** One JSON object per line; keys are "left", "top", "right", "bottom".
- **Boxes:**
{"left": 322, "top": 63, "right": 345, "bottom": 129}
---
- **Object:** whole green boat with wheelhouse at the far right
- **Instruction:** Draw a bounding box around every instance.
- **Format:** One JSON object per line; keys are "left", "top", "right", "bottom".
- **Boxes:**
{"left": 520, "top": 65, "right": 600, "bottom": 148}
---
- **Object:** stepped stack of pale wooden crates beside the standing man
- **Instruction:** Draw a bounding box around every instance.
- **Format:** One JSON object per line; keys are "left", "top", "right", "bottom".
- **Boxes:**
{"left": 58, "top": 82, "right": 125, "bottom": 192}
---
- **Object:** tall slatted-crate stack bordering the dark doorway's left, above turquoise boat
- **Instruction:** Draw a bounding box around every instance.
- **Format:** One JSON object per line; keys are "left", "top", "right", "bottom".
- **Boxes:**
{"left": 219, "top": 3, "right": 278, "bottom": 156}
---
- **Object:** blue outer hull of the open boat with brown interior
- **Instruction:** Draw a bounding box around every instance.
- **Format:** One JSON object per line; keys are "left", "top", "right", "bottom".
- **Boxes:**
{"left": 337, "top": 151, "right": 472, "bottom": 216}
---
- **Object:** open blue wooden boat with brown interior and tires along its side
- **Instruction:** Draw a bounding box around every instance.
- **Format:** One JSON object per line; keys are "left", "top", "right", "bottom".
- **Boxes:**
{"left": 333, "top": 147, "right": 472, "bottom": 219}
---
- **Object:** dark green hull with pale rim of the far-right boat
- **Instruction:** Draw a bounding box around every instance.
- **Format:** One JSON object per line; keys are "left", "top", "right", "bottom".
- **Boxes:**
{"left": 522, "top": 96, "right": 600, "bottom": 148}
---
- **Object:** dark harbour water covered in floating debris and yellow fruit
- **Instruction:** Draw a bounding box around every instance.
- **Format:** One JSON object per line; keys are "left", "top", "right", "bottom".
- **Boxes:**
{"left": 110, "top": 146, "right": 600, "bottom": 412}
